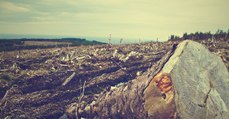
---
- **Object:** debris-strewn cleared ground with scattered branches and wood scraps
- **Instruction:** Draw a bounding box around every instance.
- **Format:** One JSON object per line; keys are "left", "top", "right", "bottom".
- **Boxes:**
{"left": 0, "top": 40, "right": 229, "bottom": 118}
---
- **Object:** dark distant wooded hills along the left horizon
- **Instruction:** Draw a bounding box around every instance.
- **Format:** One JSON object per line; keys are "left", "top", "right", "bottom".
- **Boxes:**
{"left": 0, "top": 38, "right": 105, "bottom": 51}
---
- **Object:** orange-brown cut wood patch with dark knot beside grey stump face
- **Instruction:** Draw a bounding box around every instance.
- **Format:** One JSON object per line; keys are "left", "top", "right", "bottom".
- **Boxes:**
{"left": 144, "top": 73, "right": 176, "bottom": 119}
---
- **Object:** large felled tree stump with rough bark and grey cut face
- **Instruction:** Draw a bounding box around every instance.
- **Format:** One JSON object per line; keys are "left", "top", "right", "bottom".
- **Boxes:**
{"left": 67, "top": 40, "right": 229, "bottom": 119}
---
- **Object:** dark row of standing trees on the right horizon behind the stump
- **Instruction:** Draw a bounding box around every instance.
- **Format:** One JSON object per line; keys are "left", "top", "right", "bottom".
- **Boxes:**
{"left": 169, "top": 29, "right": 229, "bottom": 40}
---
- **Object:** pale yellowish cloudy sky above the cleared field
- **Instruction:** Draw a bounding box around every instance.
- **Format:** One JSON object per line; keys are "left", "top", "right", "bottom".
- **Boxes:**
{"left": 0, "top": 0, "right": 229, "bottom": 41}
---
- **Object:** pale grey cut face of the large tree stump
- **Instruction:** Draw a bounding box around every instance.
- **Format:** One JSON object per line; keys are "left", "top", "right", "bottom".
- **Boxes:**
{"left": 162, "top": 41, "right": 229, "bottom": 119}
